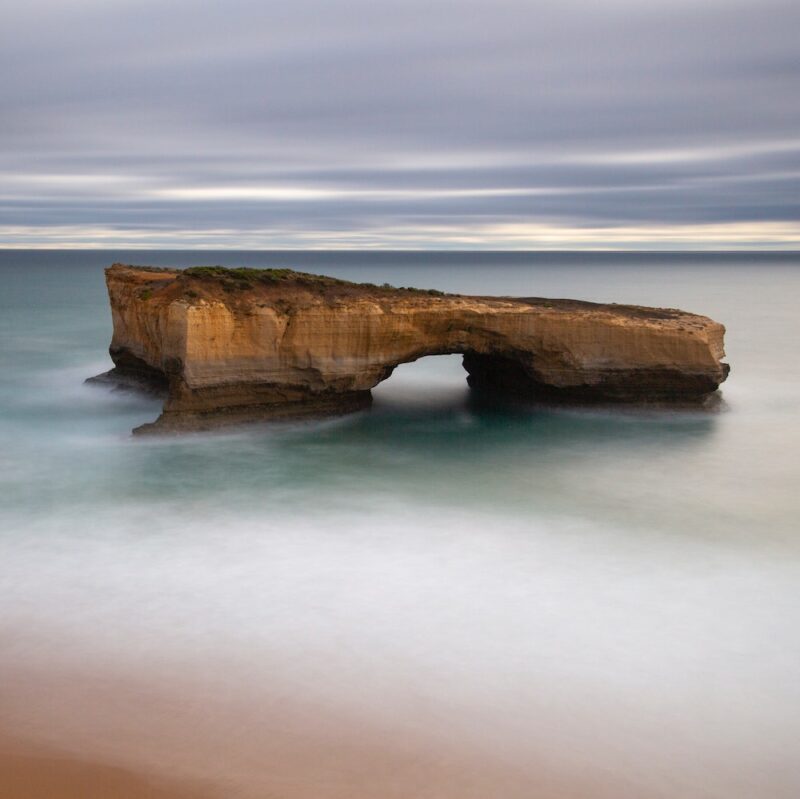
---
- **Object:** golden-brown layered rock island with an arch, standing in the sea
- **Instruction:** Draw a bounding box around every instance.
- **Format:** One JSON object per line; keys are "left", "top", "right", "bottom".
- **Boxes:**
{"left": 95, "top": 264, "right": 728, "bottom": 429}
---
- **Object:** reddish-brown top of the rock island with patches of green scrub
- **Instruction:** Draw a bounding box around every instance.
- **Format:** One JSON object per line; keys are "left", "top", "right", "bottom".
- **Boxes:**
{"left": 106, "top": 263, "right": 711, "bottom": 328}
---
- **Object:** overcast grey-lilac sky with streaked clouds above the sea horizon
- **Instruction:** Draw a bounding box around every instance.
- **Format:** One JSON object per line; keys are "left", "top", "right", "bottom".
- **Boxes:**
{"left": 0, "top": 0, "right": 800, "bottom": 250}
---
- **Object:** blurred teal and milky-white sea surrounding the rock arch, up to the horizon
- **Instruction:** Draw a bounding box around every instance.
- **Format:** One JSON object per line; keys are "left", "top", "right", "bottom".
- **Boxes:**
{"left": 0, "top": 251, "right": 800, "bottom": 799}
